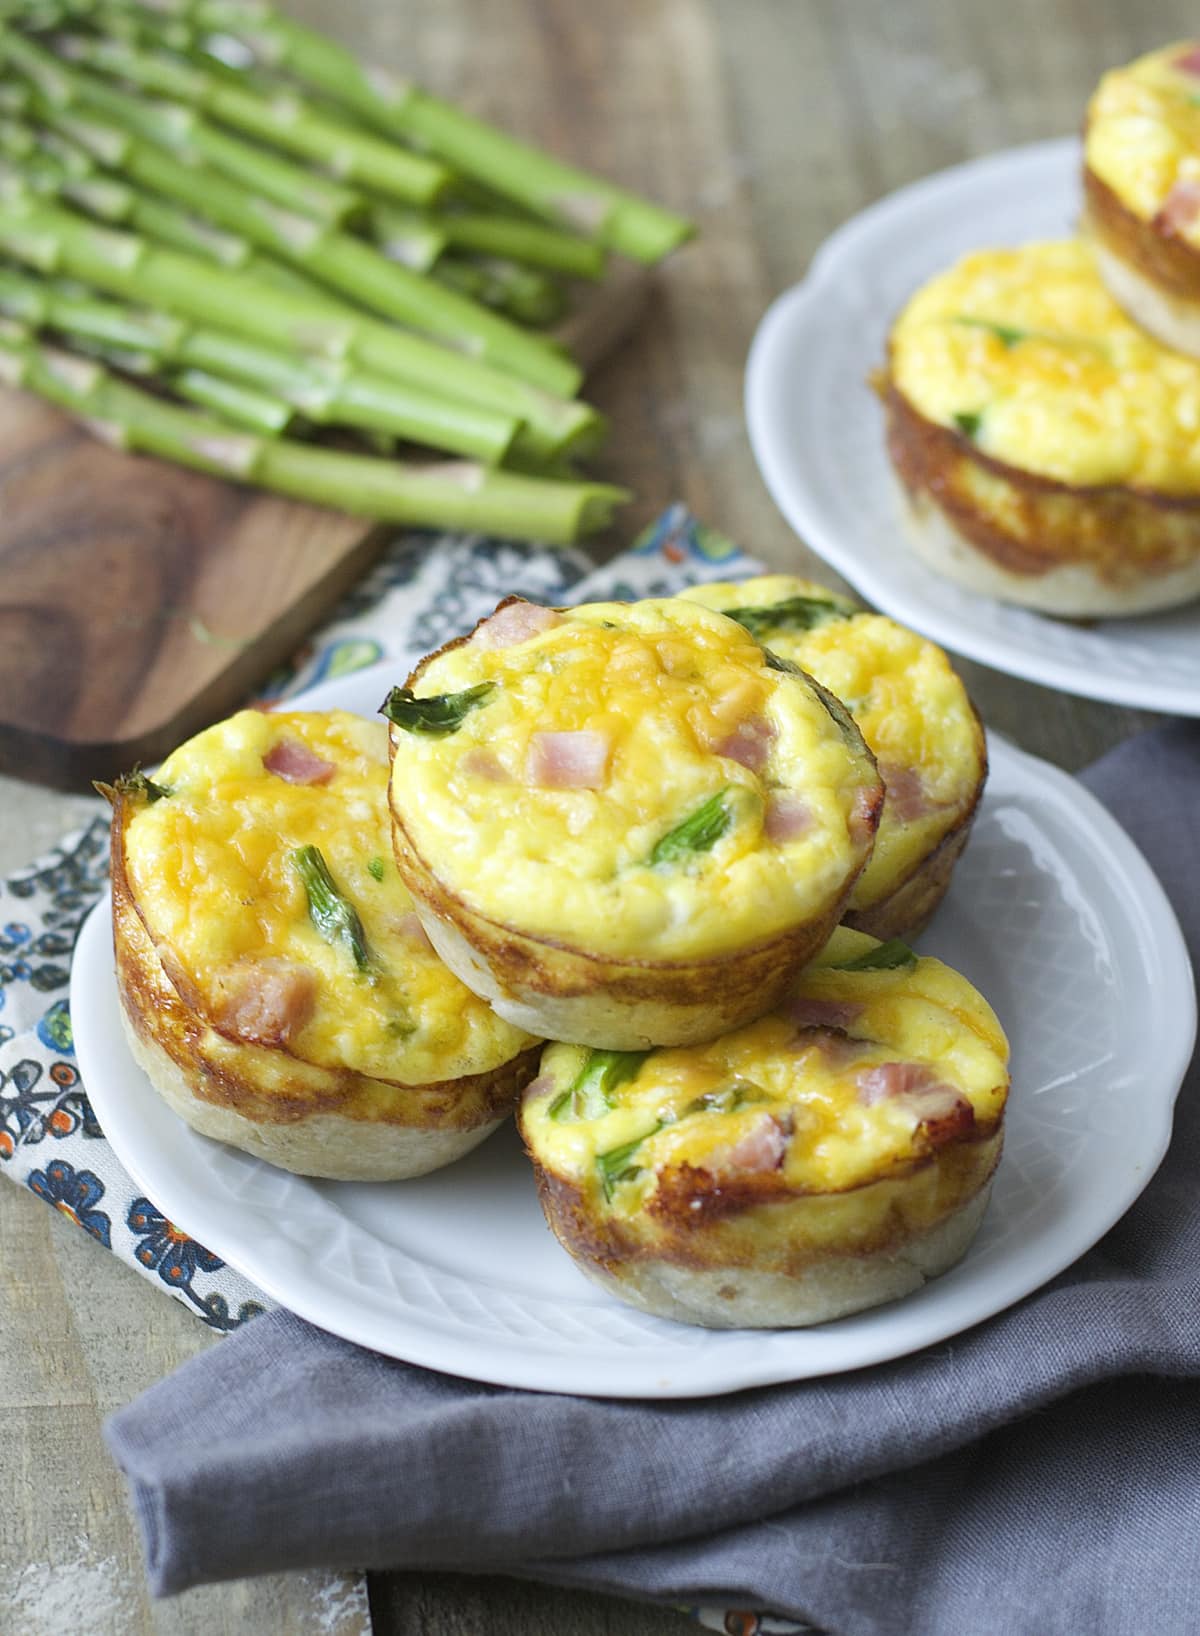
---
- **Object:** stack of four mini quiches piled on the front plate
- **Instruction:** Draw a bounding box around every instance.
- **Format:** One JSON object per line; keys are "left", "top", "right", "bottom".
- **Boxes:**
{"left": 111, "top": 576, "right": 1008, "bottom": 1327}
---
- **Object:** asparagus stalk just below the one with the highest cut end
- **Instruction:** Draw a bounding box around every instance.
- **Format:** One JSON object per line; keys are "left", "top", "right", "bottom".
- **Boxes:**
{"left": 0, "top": 29, "right": 362, "bottom": 224}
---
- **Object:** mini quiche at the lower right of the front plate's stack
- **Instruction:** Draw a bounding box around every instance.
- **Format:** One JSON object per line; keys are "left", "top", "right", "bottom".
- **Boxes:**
{"left": 517, "top": 928, "right": 1008, "bottom": 1328}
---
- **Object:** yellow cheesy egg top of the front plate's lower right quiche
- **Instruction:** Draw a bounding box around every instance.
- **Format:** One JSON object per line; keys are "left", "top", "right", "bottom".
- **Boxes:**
{"left": 521, "top": 928, "right": 1008, "bottom": 1220}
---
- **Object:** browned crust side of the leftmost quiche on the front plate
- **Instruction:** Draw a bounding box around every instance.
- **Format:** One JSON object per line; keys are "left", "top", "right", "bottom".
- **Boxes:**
{"left": 111, "top": 790, "right": 540, "bottom": 1175}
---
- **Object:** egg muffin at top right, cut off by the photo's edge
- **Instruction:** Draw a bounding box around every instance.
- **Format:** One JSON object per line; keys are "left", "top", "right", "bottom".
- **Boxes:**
{"left": 1084, "top": 39, "right": 1200, "bottom": 357}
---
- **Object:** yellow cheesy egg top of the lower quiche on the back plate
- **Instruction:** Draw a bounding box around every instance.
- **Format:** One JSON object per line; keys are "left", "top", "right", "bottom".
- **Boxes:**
{"left": 891, "top": 239, "right": 1200, "bottom": 496}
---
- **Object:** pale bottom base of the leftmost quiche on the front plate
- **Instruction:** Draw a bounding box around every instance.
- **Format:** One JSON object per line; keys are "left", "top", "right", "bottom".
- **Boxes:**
{"left": 121, "top": 1006, "right": 504, "bottom": 1181}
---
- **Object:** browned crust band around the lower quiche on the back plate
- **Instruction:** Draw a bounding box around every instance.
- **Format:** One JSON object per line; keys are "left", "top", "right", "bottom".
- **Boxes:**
{"left": 884, "top": 380, "right": 1200, "bottom": 595}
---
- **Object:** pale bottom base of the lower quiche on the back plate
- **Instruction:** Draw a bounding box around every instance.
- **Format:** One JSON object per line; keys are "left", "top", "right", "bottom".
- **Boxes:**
{"left": 897, "top": 483, "right": 1200, "bottom": 618}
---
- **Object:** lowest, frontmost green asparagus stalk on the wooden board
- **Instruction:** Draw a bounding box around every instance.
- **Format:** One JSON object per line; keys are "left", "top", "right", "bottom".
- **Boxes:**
{"left": 0, "top": 329, "right": 627, "bottom": 545}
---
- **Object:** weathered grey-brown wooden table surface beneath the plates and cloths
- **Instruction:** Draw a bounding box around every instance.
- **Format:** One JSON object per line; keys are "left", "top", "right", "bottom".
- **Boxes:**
{"left": 0, "top": 0, "right": 1195, "bottom": 1636}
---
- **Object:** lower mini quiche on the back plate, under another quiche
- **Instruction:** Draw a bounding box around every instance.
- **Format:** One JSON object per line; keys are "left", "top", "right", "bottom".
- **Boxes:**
{"left": 881, "top": 240, "right": 1200, "bottom": 617}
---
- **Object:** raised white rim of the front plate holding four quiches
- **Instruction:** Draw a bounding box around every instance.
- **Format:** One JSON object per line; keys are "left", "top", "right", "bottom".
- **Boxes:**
{"left": 70, "top": 661, "right": 1195, "bottom": 1399}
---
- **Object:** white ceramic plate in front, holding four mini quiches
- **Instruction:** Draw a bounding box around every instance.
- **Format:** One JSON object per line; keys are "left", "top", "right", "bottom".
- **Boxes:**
{"left": 70, "top": 666, "right": 1195, "bottom": 1397}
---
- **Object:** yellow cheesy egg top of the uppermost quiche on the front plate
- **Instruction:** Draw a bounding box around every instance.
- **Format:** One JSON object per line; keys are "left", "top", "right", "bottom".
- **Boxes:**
{"left": 393, "top": 600, "right": 877, "bottom": 959}
